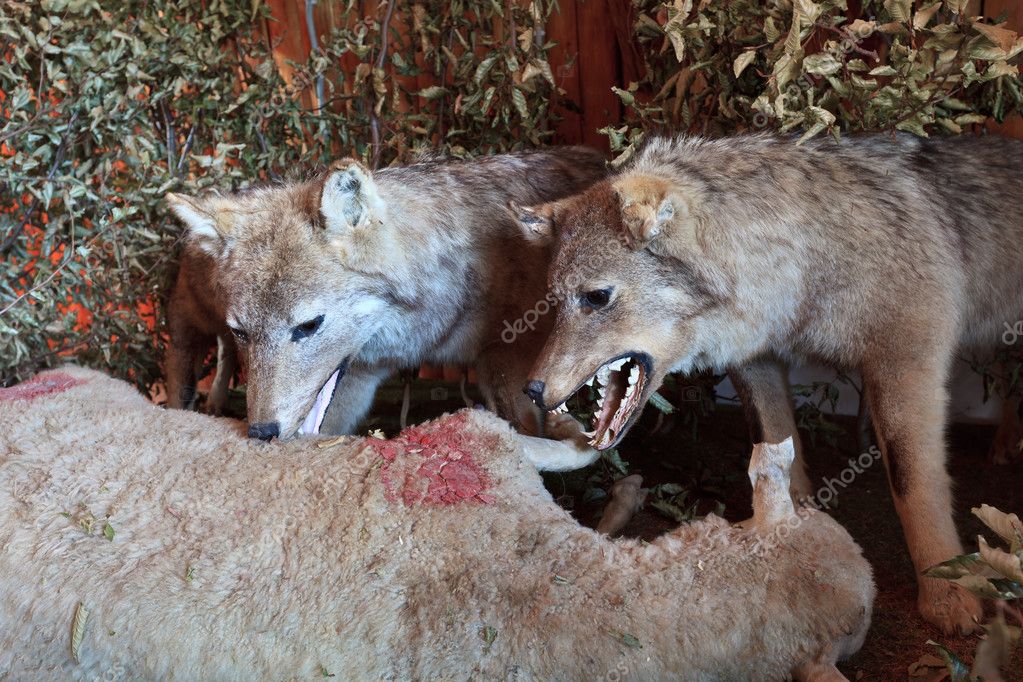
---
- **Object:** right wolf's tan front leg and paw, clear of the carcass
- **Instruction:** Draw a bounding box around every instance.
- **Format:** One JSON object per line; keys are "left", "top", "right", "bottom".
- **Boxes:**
{"left": 862, "top": 351, "right": 983, "bottom": 633}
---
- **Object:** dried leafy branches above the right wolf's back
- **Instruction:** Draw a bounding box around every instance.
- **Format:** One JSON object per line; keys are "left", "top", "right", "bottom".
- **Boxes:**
{"left": 605, "top": 0, "right": 1023, "bottom": 163}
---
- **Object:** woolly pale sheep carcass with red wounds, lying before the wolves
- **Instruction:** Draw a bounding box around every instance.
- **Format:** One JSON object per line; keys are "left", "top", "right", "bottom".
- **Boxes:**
{"left": 0, "top": 368, "right": 874, "bottom": 680}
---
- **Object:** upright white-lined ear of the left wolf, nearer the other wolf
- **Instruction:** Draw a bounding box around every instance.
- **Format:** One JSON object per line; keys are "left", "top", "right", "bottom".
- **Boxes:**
{"left": 320, "top": 158, "right": 384, "bottom": 233}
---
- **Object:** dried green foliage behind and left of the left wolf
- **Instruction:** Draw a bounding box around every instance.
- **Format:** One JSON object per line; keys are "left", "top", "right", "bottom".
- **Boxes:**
{"left": 0, "top": 0, "right": 553, "bottom": 388}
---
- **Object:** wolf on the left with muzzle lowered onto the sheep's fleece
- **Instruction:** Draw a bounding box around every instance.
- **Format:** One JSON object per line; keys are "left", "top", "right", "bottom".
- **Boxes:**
{"left": 168, "top": 147, "right": 605, "bottom": 458}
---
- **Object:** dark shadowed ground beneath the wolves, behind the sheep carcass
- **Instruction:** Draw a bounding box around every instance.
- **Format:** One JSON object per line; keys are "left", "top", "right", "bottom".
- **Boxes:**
{"left": 237, "top": 380, "right": 1023, "bottom": 682}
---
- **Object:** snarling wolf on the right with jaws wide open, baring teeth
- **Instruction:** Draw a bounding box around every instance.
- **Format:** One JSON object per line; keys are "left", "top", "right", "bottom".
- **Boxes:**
{"left": 517, "top": 135, "right": 1023, "bottom": 630}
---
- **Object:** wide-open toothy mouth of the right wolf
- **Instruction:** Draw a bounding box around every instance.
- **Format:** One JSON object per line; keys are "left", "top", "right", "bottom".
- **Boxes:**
{"left": 550, "top": 353, "right": 652, "bottom": 450}
